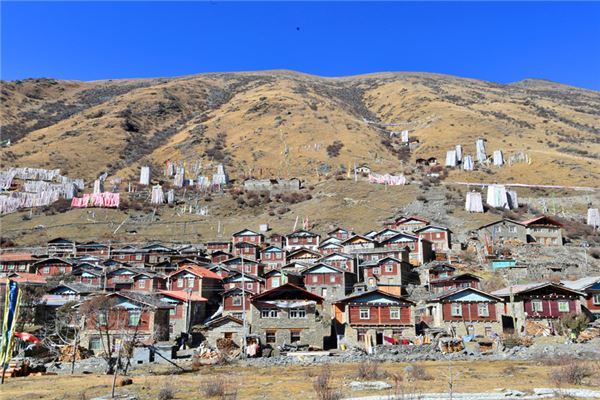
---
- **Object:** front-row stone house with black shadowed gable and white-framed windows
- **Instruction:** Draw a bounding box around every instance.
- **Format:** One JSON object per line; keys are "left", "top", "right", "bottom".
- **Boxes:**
{"left": 251, "top": 283, "right": 330, "bottom": 348}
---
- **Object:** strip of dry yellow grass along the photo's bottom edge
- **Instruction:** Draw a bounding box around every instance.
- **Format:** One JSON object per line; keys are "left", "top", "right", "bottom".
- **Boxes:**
{"left": 2, "top": 361, "right": 600, "bottom": 400}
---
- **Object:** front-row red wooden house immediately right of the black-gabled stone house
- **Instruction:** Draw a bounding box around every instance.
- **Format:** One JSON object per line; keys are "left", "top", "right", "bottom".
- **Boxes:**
{"left": 335, "top": 290, "right": 415, "bottom": 347}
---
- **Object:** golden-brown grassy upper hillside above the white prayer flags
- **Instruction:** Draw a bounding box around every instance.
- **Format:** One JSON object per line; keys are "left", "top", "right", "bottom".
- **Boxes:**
{"left": 0, "top": 71, "right": 600, "bottom": 186}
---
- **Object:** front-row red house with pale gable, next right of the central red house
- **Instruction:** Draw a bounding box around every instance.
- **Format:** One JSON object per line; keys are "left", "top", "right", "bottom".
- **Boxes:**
{"left": 426, "top": 287, "right": 504, "bottom": 337}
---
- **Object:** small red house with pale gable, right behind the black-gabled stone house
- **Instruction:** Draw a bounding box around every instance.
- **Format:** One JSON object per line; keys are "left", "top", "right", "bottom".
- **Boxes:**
{"left": 302, "top": 263, "right": 356, "bottom": 300}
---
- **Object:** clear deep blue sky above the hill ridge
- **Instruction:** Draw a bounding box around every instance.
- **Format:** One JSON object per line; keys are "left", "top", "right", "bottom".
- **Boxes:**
{"left": 0, "top": 1, "right": 600, "bottom": 90}
